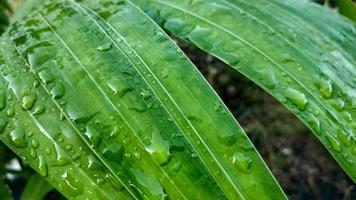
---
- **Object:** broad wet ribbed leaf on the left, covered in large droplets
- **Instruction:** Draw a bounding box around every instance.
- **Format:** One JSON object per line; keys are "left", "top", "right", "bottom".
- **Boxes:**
{"left": 0, "top": 1, "right": 285, "bottom": 199}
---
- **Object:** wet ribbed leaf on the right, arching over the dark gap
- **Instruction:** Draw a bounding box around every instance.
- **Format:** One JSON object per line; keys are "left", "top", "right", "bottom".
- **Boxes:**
{"left": 135, "top": 0, "right": 356, "bottom": 181}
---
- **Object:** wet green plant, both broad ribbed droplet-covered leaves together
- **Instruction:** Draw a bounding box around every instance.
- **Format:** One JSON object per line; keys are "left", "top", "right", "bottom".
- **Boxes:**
{"left": 0, "top": 0, "right": 356, "bottom": 199}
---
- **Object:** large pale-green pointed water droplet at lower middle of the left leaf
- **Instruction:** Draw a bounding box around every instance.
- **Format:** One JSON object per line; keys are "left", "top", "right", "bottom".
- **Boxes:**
{"left": 146, "top": 129, "right": 171, "bottom": 165}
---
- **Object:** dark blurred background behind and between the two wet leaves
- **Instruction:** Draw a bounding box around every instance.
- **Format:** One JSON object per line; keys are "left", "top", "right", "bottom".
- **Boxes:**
{"left": 0, "top": 0, "right": 356, "bottom": 200}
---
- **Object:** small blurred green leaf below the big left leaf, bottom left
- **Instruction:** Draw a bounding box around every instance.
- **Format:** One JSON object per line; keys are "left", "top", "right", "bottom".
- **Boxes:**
{"left": 21, "top": 174, "right": 53, "bottom": 200}
